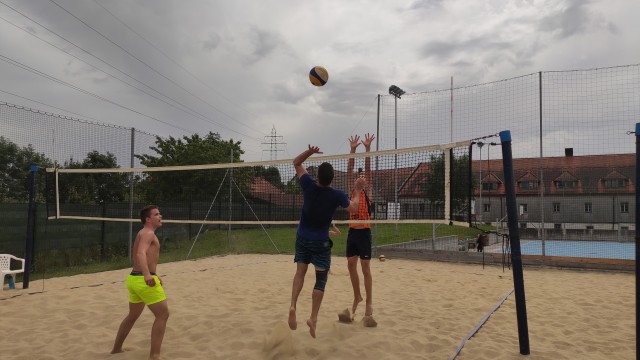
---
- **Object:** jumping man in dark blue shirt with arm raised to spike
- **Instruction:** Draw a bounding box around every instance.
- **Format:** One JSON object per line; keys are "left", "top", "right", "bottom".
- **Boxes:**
{"left": 289, "top": 145, "right": 365, "bottom": 338}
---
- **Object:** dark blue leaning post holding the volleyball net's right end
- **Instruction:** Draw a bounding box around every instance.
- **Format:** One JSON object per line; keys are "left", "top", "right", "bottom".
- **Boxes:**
{"left": 500, "top": 130, "right": 530, "bottom": 355}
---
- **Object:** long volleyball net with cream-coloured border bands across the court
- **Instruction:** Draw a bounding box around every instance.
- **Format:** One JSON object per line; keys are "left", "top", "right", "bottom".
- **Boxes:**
{"left": 47, "top": 141, "right": 472, "bottom": 226}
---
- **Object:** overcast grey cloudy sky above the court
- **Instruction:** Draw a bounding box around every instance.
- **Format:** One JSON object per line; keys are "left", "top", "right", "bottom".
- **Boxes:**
{"left": 0, "top": 0, "right": 640, "bottom": 161}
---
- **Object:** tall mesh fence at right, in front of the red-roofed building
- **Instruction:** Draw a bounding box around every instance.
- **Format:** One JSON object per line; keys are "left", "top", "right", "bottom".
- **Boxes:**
{"left": 378, "top": 64, "right": 640, "bottom": 259}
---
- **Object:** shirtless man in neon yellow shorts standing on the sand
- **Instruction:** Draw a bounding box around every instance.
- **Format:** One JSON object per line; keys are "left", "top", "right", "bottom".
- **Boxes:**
{"left": 111, "top": 205, "right": 169, "bottom": 360}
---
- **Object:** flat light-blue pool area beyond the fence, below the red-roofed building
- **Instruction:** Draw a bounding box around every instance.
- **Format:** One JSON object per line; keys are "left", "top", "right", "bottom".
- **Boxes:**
{"left": 495, "top": 240, "right": 635, "bottom": 260}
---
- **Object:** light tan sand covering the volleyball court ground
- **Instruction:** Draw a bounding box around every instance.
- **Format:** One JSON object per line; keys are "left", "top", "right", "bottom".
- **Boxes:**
{"left": 0, "top": 255, "right": 635, "bottom": 360}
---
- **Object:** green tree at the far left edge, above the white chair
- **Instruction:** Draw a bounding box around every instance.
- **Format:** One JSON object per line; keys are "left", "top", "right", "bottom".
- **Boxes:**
{"left": 0, "top": 136, "right": 53, "bottom": 202}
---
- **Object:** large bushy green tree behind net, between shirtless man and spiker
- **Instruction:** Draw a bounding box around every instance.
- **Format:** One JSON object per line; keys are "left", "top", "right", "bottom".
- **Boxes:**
{"left": 136, "top": 132, "right": 245, "bottom": 202}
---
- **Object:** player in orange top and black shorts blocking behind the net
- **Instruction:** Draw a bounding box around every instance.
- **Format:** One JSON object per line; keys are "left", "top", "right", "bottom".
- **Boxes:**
{"left": 346, "top": 133, "right": 375, "bottom": 326}
